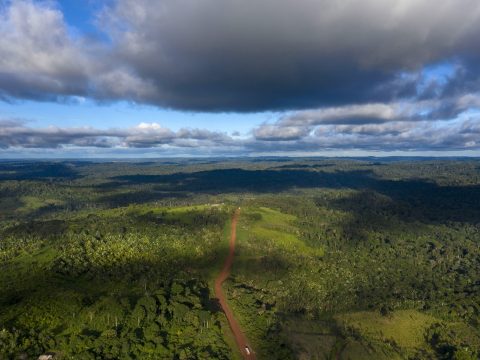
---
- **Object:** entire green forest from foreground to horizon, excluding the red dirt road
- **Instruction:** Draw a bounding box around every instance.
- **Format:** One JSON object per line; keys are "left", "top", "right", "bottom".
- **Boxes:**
{"left": 0, "top": 158, "right": 480, "bottom": 360}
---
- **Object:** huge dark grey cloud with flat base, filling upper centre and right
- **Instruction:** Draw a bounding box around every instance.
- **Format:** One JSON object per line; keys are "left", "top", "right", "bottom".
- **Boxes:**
{"left": 99, "top": 0, "right": 480, "bottom": 111}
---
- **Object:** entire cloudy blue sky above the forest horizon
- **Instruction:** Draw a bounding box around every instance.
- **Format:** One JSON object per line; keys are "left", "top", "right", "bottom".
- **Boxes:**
{"left": 0, "top": 0, "right": 480, "bottom": 158}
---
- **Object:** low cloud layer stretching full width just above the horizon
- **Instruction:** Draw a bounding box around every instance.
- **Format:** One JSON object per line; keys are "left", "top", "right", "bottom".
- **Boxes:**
{"left": 0, "top": 117, "right": 480, "bottom": 155}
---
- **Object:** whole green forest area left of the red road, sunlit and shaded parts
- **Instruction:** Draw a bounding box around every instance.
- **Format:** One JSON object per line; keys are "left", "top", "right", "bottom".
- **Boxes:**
{"left": 0, "top": 201, "right": 230, "bottom": 359}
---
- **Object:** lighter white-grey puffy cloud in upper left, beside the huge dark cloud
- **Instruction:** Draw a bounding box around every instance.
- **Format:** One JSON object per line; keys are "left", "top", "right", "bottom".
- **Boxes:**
{"left": 0, "top": 0, "right": 156, "bottom": 102}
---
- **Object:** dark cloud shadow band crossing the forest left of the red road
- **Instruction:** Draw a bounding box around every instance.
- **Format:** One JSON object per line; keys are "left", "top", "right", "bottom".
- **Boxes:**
{"left": 0, "top": 231, "right": 228, "bottom": 316}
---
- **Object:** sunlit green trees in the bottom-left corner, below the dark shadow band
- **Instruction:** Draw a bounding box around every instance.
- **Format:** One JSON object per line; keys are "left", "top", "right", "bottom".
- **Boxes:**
{"left": 0, "top": 280, "right": 230, "bottom": 359}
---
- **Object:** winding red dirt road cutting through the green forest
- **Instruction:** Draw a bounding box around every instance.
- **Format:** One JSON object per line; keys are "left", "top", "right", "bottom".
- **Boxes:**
{"left": 215, "top": 208, "right": 256, "bottom": 360}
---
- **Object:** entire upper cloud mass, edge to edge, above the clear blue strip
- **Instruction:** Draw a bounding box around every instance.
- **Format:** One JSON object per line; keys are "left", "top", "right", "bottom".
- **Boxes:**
{"left": 0, "top": 0, "right": 480, "bottom": 112}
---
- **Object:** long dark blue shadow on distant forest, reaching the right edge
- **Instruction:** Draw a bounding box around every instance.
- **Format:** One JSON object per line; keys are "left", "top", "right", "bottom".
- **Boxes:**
{"left": 102, "top": 169, "right": 480, "bottom": 224}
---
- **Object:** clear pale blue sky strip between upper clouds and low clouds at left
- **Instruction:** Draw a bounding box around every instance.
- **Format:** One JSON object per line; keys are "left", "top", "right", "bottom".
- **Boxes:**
{"left": 0, "top": 99, "right": 268, "bottom": 135}
